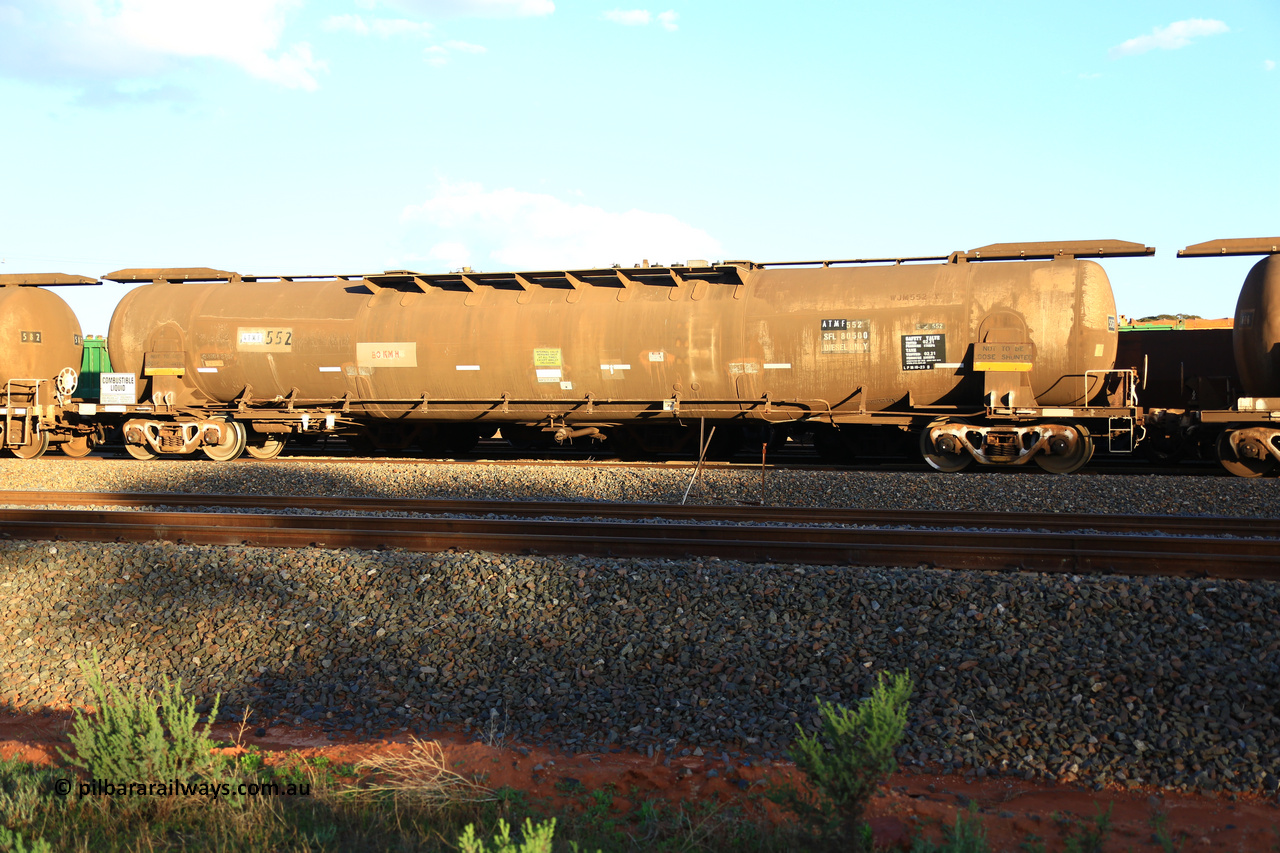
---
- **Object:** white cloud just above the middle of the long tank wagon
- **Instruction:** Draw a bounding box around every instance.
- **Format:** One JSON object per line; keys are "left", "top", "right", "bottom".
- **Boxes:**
{"left": 402, "top": 183, "right": 721, "bottom": 269}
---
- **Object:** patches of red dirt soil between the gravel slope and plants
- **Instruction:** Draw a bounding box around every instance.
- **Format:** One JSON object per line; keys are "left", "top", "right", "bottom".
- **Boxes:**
{"left": 0, "top": 712, "right": 1280, "bottom": 853}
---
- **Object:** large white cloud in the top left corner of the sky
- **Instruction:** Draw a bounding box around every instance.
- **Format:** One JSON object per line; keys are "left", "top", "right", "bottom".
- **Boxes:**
{"left": 0, "top": 0, "right": 325, "bottom": 90}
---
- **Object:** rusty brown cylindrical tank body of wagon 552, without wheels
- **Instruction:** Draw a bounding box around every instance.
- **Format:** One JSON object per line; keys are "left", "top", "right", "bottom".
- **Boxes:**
{"left": 106, "top": 241, "right": 1146, "bottom": 423}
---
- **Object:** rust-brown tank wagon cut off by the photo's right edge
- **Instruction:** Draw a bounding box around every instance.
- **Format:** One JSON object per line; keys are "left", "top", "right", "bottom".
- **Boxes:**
{"left": 1178, "top": 237, "right": 1280, "bottom": 476}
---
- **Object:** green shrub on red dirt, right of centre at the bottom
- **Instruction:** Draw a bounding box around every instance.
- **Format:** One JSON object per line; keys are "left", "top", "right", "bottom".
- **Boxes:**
{"left": 772, "top": 672, "right": 913, "bottom": 849}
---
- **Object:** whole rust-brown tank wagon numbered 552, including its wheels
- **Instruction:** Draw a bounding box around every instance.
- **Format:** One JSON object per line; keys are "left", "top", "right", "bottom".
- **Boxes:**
{"left": 105, "top": 241, "right": 1153, "bottom": 470}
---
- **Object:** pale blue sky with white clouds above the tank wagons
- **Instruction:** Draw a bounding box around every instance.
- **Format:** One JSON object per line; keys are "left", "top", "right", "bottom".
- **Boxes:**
{"left": 0, "top": 0, "right": 1280, "bottom": 333}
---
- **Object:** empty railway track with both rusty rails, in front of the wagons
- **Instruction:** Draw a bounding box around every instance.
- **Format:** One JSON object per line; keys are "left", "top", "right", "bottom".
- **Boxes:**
{"left": 0, "top": 492, "right": 1280, "bottom": 580}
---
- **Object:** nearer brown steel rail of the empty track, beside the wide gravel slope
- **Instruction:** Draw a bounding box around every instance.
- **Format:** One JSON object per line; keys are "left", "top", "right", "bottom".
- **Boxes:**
{"left": 0, "top": 510, "right": 1280, "bottom": 580}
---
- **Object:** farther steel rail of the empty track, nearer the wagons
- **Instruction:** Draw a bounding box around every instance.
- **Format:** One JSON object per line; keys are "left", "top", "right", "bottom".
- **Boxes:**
{"left": 0, "top": 491, "right": 1264, "bottom": 535}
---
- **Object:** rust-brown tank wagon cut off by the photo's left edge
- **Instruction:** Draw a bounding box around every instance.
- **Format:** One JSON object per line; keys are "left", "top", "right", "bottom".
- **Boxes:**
{"left": 0, "top": 273, "right": 97, "bottom": 459}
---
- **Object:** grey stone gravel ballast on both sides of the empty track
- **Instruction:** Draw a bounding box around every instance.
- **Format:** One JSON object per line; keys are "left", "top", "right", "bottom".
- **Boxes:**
{"left": 0, "top": 461, "right": 1280, "bottom": 793}
